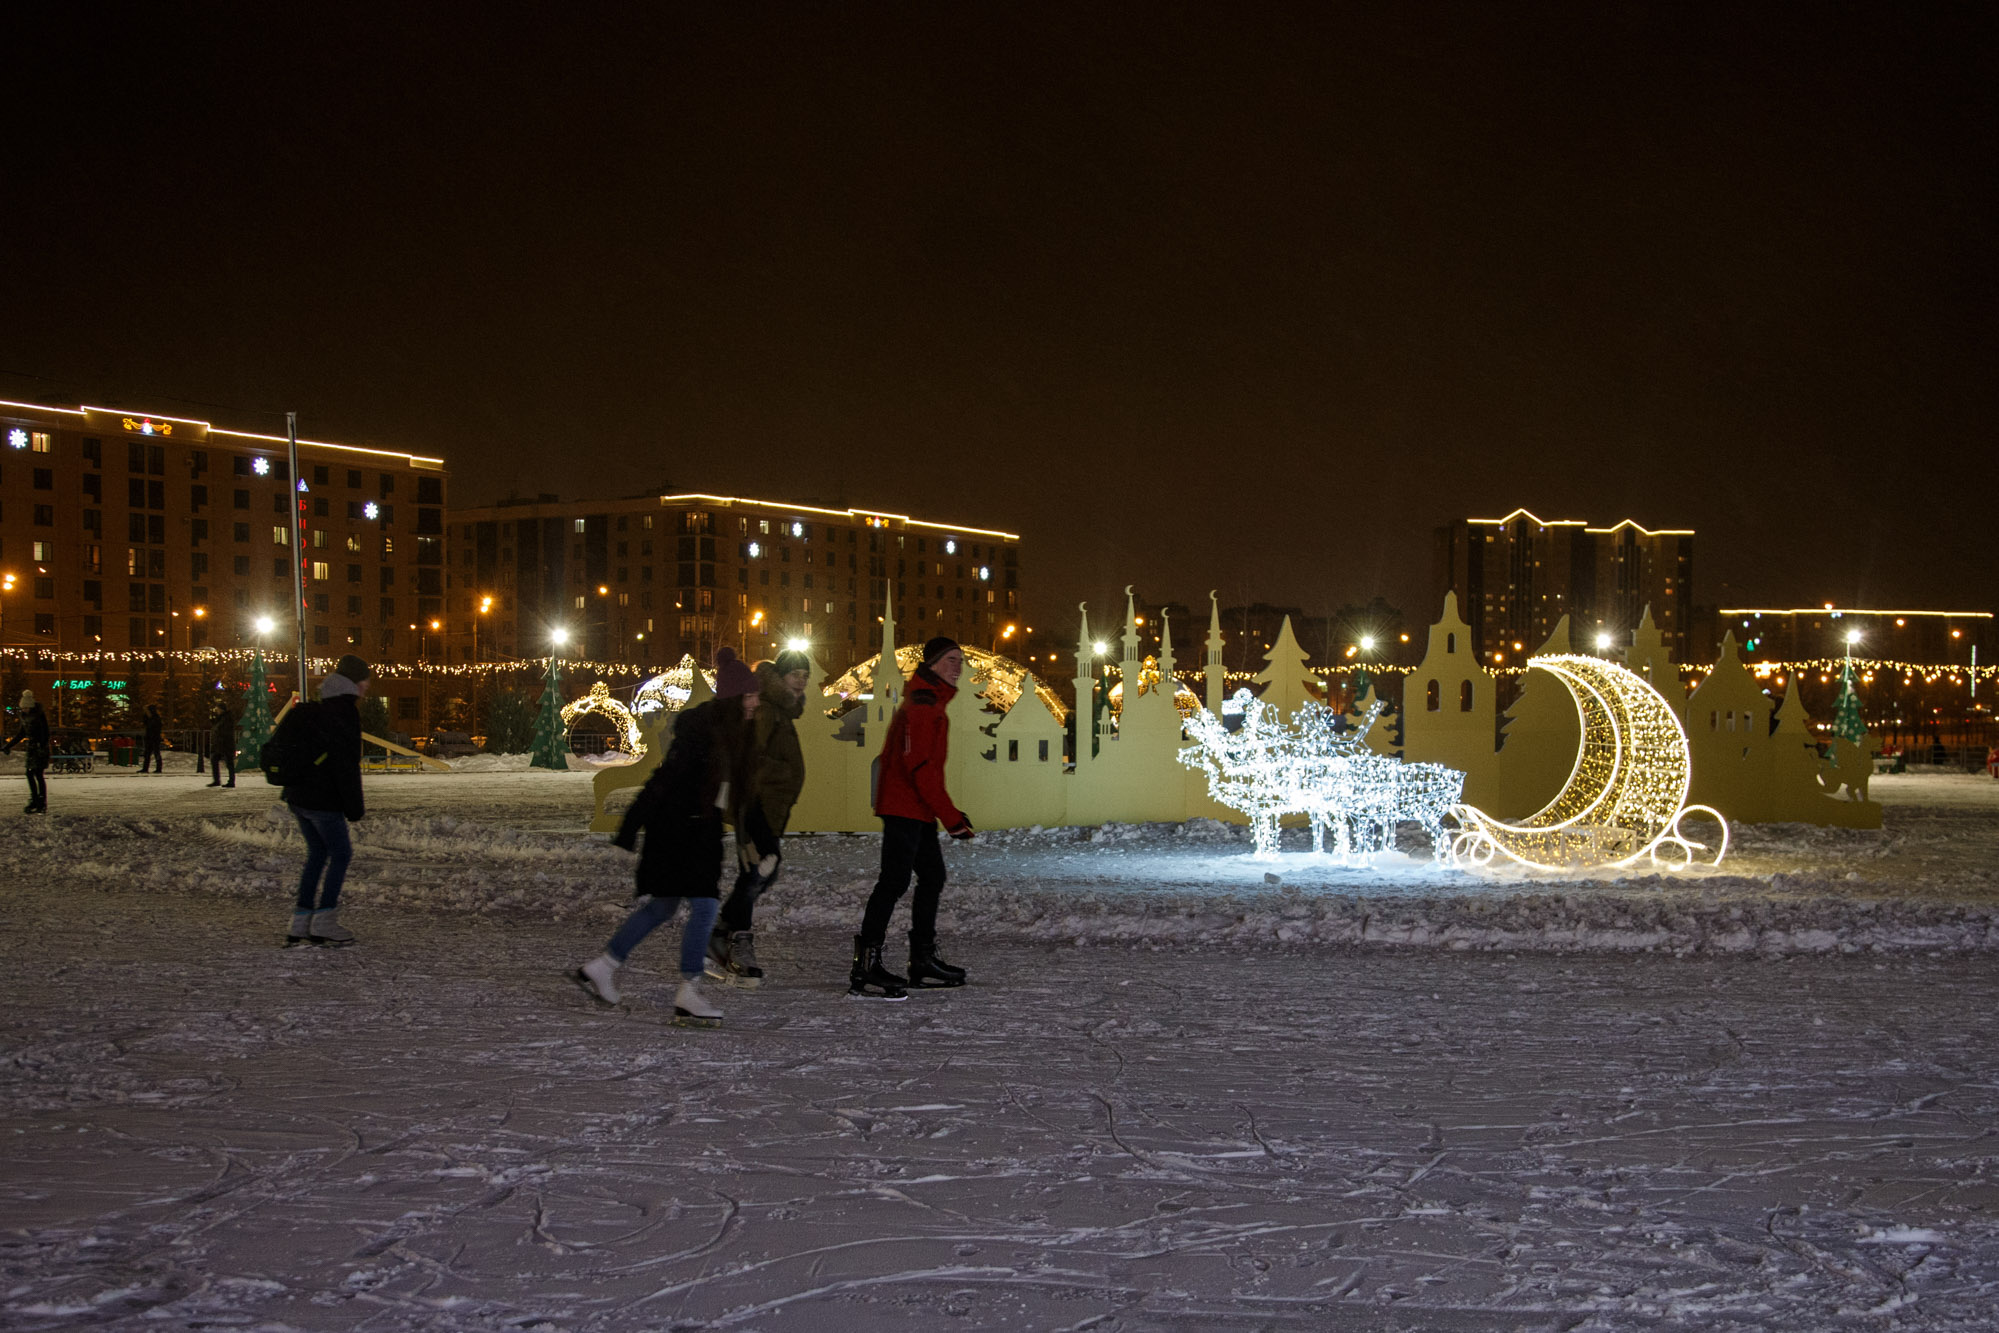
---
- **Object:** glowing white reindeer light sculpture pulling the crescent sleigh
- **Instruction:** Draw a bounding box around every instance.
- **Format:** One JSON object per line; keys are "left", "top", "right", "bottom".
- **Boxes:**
{"left": 1179, "top": 689, "right": 1465, "bottom": 859}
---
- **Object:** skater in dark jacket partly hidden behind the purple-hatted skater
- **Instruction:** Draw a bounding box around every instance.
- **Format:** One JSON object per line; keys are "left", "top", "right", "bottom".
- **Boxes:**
{"left": 708, "top": 648, "right": 812, "bottom": 985}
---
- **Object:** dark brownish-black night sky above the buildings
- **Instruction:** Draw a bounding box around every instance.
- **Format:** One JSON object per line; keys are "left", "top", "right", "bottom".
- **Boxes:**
{"left": 0, "top": 4, "right": 1999, "bottom": 636}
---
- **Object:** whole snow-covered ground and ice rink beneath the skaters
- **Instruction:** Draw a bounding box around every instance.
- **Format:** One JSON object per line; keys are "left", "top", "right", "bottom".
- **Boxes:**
{"left": 0, "top": 759, "right": 1999, "bottom": 1331}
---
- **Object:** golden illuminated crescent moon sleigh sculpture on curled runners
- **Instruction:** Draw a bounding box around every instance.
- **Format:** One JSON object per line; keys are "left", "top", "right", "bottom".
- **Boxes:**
{"left": 1451, "top": 654, "right": 1729, "bottom": 869}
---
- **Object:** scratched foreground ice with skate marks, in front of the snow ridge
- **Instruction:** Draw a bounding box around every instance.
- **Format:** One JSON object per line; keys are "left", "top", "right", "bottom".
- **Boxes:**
{"left": 0, "top": 891, "right": 1999, "bottom": 1331}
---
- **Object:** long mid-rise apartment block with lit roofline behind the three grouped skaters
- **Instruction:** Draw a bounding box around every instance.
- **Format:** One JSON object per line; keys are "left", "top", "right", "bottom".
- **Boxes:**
{"left": 444, "top": 496, "right": 1019, "bottom": 669}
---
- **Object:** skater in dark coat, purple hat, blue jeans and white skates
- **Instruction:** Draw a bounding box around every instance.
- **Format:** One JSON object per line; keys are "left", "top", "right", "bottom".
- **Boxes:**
{"left": 570, "top": 648, "right": 762, "bottom": 1023}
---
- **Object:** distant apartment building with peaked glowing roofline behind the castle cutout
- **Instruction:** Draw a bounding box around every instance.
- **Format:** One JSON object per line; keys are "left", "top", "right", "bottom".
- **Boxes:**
{"left": 1435, "top": 510, "right": 1693, "bottom": 666}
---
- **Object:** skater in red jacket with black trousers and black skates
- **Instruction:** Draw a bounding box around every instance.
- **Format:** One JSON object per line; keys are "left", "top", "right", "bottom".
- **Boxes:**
{"left": 848, "top": 636, "right": 972, "bottom": 999}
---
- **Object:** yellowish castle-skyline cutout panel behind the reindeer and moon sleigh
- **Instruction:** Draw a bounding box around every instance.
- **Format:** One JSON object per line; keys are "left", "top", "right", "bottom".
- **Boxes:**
{"left": 559, "top": 590, "right": 1881, "bottom": 835}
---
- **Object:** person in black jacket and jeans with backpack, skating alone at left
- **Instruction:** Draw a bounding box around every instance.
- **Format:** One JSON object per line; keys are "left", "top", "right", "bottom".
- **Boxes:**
{"left": 283, "top": 654, "right": 374, "bottom": 947}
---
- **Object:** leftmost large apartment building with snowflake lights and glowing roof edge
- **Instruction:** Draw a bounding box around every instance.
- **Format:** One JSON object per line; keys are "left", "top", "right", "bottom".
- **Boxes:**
{"left": 0, "top": 402, "right": 446, "bottom": 662}
